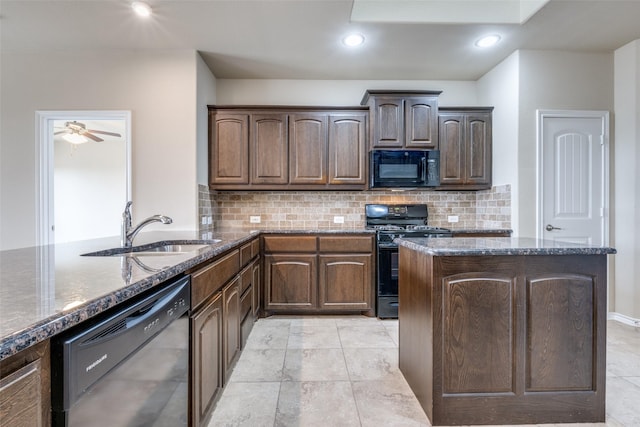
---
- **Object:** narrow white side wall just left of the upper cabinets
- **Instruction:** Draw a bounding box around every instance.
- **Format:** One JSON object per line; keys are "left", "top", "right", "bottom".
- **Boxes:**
{"left": 196, "top": 54, "right": 216, "bottom": 185}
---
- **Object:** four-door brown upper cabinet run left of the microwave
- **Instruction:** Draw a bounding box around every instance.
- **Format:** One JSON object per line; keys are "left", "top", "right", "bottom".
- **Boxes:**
{"left": 209, "top": 107, "right": 369, "bottom": 190}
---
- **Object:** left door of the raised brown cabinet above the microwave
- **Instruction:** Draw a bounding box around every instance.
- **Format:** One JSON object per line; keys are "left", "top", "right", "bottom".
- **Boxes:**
{"left": 371, "top": 97, "right": 404, "bottom": 148}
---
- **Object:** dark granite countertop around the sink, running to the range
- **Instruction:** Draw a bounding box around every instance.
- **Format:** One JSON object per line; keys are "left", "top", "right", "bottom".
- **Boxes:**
{"left": 0, "top": 229, "right": 374, "bottom": 360}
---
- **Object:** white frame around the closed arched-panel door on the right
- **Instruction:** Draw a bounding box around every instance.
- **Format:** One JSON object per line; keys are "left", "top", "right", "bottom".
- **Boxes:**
{"left": 536, "top": 109, "right": 610, "bottom": 246}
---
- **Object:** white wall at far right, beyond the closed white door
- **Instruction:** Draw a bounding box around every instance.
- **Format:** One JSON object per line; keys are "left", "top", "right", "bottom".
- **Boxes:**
{"left": 610, "top": 40, "right": 640, "bottom": 319}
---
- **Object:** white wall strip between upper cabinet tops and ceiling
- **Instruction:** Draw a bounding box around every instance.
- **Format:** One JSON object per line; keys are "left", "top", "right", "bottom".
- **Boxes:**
{"left": 216, "top": 79, "right": 478, "bottom": 107}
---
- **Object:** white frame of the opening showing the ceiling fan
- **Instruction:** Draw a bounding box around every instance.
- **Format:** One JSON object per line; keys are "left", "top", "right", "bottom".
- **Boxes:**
{"left": 35, "top": 110, "right": 131, "bottom": 246}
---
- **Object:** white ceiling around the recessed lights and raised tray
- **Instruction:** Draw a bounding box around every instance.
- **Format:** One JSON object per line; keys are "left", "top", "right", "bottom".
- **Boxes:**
{"left": 0, "top": 0, "right": 640, "bottom": 80}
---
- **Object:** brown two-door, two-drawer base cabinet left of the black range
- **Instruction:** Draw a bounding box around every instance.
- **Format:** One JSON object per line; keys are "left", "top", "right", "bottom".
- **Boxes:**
{"left": 264, "top": 235, "right": 374, "bottom": 315}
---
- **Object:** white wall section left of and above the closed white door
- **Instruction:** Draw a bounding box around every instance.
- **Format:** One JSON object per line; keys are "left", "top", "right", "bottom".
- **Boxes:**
{"left": 517, "top": 50, "right": 613, "bottom": 237}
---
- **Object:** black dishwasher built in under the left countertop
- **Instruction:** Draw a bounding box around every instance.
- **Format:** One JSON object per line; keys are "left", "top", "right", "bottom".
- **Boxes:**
{"left": 51, "top": 276, "right": 191, "bottom": 427}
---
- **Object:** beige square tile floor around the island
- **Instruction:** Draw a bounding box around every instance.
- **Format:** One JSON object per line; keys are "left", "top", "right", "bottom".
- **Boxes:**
{"left": 209, "top": 317, "right": 640, "bottom": 427}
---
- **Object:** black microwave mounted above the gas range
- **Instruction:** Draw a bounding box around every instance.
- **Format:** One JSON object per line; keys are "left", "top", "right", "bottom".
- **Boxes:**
{"left": 369, "top": 150, "right": 440, "bottom": 188}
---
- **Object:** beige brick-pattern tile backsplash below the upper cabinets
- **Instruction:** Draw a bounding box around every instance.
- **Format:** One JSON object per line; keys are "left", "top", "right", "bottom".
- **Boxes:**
{"left": 198, "top": 184, "right": 511, "bottom": 231}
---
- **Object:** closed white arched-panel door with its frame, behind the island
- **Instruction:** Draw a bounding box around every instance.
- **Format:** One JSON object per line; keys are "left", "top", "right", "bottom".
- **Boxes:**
{"left": 537, "top": 111, "right": 609, "bottom": 246}
